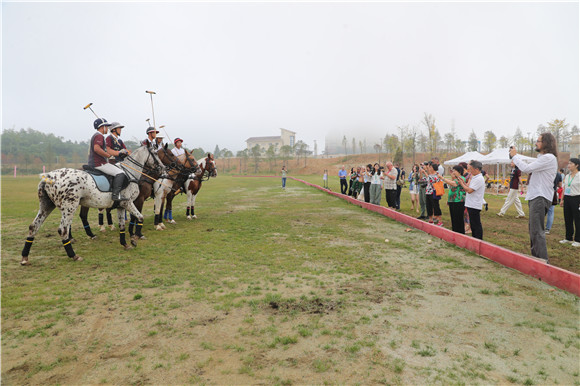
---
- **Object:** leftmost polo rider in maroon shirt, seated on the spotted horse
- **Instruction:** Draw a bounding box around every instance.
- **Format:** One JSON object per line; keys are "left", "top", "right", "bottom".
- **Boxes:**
{"left": 88, "top": 118, "right": 128, "bottom": 202}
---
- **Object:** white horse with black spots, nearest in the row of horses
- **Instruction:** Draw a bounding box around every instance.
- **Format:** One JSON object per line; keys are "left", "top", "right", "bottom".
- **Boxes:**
{"left": 20, "top": 146, "right": 163, "bottom": 265}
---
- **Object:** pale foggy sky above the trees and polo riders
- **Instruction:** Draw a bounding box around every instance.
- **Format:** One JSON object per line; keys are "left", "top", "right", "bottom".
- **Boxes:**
{"left": 2, "top": 2, "right": 580, "bottom": 153}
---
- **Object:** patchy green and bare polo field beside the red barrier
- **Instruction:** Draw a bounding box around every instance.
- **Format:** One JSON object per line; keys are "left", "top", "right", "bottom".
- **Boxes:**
{"left": 2, "top": 176, "right": 580, "bottom": 385}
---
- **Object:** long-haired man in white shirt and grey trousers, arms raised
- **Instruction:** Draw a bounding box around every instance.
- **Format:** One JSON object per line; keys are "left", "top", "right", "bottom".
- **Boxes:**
{"left": 510, "top": 133, "right": 558, "bottom": 263}
